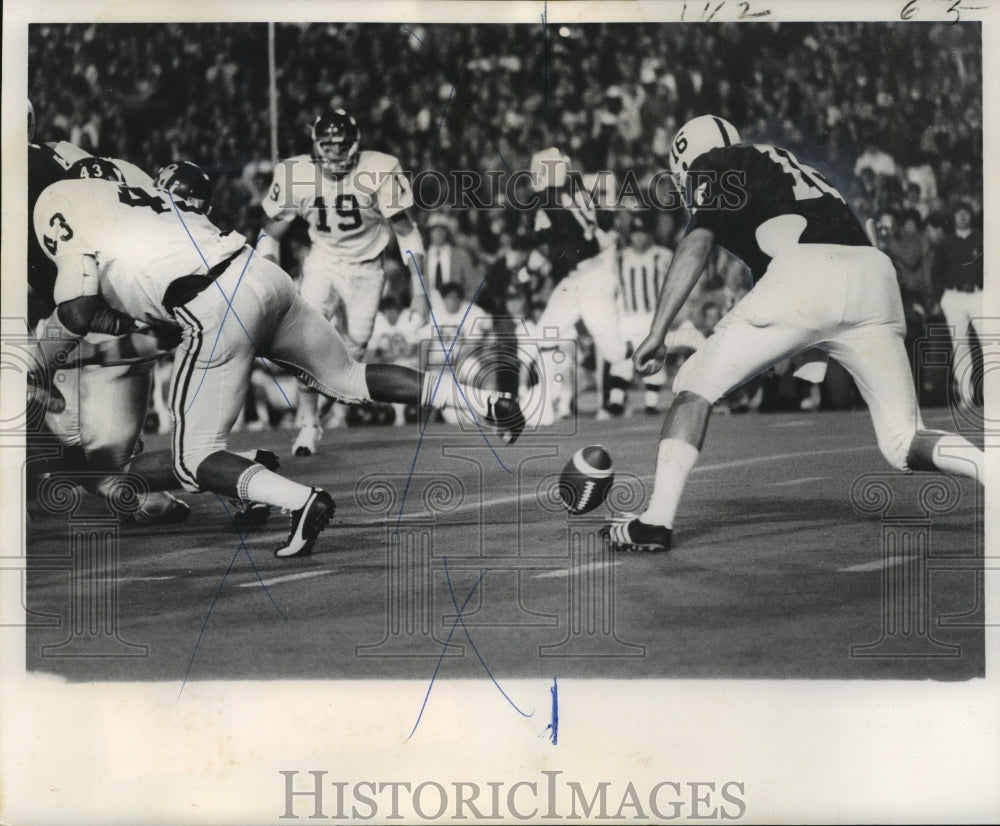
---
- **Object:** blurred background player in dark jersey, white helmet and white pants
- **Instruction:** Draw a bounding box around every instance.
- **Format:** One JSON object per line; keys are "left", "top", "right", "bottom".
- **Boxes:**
{"left": 519, "top": 147, "right": 632, "bottom": 423}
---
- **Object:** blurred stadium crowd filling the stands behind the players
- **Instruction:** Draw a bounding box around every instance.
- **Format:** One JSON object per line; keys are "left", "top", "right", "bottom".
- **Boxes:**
{"left": 29, "top": 23, "right": 983, "bottom": 418}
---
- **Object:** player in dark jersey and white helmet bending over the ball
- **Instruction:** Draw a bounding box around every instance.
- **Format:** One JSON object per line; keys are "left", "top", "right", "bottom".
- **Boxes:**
{"left": 609, "top": 115, "right": 984, "bottom": 551}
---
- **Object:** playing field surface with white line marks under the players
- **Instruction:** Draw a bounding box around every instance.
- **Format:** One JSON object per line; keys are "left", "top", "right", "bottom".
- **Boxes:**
{"left": 26, "top": 400, "right": 984, "bottom": 686}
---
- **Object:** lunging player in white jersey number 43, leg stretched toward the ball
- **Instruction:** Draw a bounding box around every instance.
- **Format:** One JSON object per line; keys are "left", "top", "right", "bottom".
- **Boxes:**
{"left": 34, "top": 161, "right": 524, "bottom": 557}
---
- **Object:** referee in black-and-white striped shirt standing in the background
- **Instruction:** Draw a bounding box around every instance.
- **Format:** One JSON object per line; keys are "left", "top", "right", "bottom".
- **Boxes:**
{"left": 607, "top": 214, "right": 704, "bottom": 415}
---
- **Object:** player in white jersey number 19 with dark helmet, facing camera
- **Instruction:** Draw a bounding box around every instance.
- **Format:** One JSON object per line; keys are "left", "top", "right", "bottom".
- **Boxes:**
{"left": 257, "top": 109, "right": 427, "bottom": 456}
